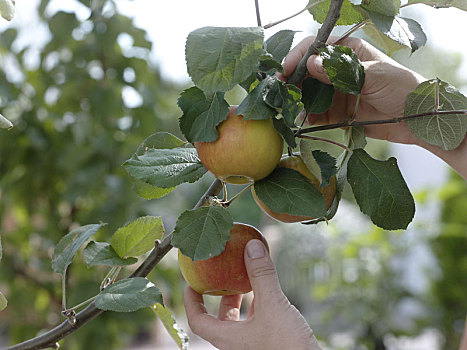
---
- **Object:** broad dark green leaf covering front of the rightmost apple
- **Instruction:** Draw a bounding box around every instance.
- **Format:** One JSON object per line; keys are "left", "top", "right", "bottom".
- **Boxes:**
{"left": 254, "top": 168, "right": 326, "bottom": 217}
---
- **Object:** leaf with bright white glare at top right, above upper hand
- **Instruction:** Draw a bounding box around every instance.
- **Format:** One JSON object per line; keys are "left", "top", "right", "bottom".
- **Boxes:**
{"left": 365, "top": 11, "right": 426, "bottom": 55}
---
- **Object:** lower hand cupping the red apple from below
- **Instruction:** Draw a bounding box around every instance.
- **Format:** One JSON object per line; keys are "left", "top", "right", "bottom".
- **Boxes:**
{"left": 185, "top": 239, "right": 321, "bottom": 350}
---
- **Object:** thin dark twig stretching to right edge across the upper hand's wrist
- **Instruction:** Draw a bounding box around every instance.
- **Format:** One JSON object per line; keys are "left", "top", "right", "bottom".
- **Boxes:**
{"left": 296, "top": 109, "right": 467, "bottom": 135}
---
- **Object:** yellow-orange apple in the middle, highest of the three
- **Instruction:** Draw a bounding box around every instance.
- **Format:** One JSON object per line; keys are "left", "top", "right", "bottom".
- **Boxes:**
{"left": 195, "top": 106, "right": 283, "bottom": 184}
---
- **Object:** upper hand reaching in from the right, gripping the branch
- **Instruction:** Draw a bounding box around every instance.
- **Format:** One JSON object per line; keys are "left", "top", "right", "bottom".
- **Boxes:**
{"left": 281, "top": 37, "right": 467, "bottom": 179}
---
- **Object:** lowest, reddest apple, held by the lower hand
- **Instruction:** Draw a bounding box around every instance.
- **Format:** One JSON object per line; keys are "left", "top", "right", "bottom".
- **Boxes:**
{"left": 178, "top": 223, "right": 269, "bottom": 295}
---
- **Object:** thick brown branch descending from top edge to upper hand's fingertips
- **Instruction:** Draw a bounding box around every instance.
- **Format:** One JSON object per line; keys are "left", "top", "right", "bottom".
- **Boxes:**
{"left": 287, "top": 0, "right": 344, "bottom": 85}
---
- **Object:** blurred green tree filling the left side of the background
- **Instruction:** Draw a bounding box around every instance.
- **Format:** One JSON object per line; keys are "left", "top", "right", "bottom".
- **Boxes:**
{"left": 0, "top": 0, "right": 186, "bottom": 349}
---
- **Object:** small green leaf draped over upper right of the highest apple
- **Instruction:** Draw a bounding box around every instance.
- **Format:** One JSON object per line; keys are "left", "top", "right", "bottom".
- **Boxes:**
{"left": 237, "top": 78, "right": 277, "bottom": 120}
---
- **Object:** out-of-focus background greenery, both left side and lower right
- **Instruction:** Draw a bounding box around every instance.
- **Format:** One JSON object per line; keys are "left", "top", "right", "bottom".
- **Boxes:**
{"left": 0, "top": 0, "right": 467, "bottom": 350}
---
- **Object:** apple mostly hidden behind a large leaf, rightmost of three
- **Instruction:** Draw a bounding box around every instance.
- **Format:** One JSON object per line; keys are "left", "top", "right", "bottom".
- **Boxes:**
{"left": 251, "top": 155, "right": 337, "bottom": 222}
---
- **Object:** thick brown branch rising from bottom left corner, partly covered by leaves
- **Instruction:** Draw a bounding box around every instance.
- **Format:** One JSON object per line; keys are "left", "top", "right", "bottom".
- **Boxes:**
{"left": 7, "top": 179, "right": 222, "bottom": 350}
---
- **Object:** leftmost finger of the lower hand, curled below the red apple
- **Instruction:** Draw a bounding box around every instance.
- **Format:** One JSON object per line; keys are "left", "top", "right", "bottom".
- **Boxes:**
{"left": 184, "top": 287, "right": 232, "bottom": 343}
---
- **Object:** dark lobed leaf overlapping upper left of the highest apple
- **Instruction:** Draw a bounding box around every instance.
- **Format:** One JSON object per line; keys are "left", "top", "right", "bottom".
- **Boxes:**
{"left": 177, "top": 87, "right": 229, "bottom": 143}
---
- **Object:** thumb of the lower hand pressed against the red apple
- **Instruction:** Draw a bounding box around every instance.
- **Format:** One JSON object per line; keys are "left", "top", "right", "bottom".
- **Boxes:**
{"left": 244, "top": 239, "right": 284, "bottom": 306}
